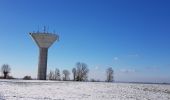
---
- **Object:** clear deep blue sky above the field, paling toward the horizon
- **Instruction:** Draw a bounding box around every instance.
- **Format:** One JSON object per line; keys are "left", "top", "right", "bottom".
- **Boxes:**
{"left": 0, "top": 0, "right": 170, "bottom": 82}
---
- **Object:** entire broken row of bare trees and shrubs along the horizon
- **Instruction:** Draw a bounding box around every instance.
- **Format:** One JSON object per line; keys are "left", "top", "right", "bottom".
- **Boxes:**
{"left": 1, "top": 62, "right": 114, "bottom": 82}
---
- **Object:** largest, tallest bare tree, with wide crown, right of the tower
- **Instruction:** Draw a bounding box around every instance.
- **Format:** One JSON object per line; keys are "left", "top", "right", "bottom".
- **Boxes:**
{"left": 76, "top": 62, "right": 89, "bottom": 81}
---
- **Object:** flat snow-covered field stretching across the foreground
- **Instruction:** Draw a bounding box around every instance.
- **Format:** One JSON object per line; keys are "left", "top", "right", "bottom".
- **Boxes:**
{"left": 0, "top": 80, "right": 170, "bottom": 100}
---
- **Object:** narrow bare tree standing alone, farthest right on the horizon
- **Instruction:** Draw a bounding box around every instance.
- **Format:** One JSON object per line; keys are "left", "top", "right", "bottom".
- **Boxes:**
{"left": 106, "top": 67, "right": 114, "bottom": 82}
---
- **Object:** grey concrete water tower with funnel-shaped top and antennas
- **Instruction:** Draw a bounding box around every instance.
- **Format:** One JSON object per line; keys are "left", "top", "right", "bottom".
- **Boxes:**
{"left": 29, "top": 28, "right": 59, "bottom": 80}
